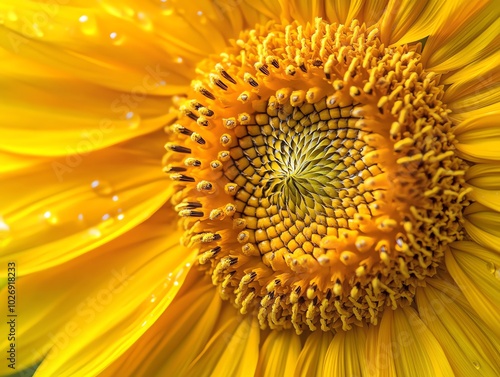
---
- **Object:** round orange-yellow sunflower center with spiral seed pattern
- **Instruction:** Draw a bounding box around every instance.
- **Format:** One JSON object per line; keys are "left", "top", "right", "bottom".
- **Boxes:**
{"left": 165, "top": 19, "right": 467, "bottom": 333}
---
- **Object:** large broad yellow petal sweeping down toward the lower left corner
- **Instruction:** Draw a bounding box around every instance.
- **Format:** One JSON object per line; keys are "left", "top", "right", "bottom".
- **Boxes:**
{"left": 0, "top": 214, "right": 195, "bottom": 377}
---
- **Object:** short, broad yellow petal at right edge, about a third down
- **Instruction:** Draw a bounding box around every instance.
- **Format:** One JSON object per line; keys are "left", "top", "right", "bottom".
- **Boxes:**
{"left": 455, "top": 110, "right": 500, "bottom": 162}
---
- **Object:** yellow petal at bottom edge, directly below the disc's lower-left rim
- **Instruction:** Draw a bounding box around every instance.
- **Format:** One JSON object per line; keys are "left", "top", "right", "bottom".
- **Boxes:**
{"left": 187, "top": 314, "right": 260, "bottom": 377}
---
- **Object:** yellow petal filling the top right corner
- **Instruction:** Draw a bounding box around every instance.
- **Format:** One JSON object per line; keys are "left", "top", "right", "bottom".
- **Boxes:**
{"left": 422, "top": 0, "right": 500, "bottom": 73}
